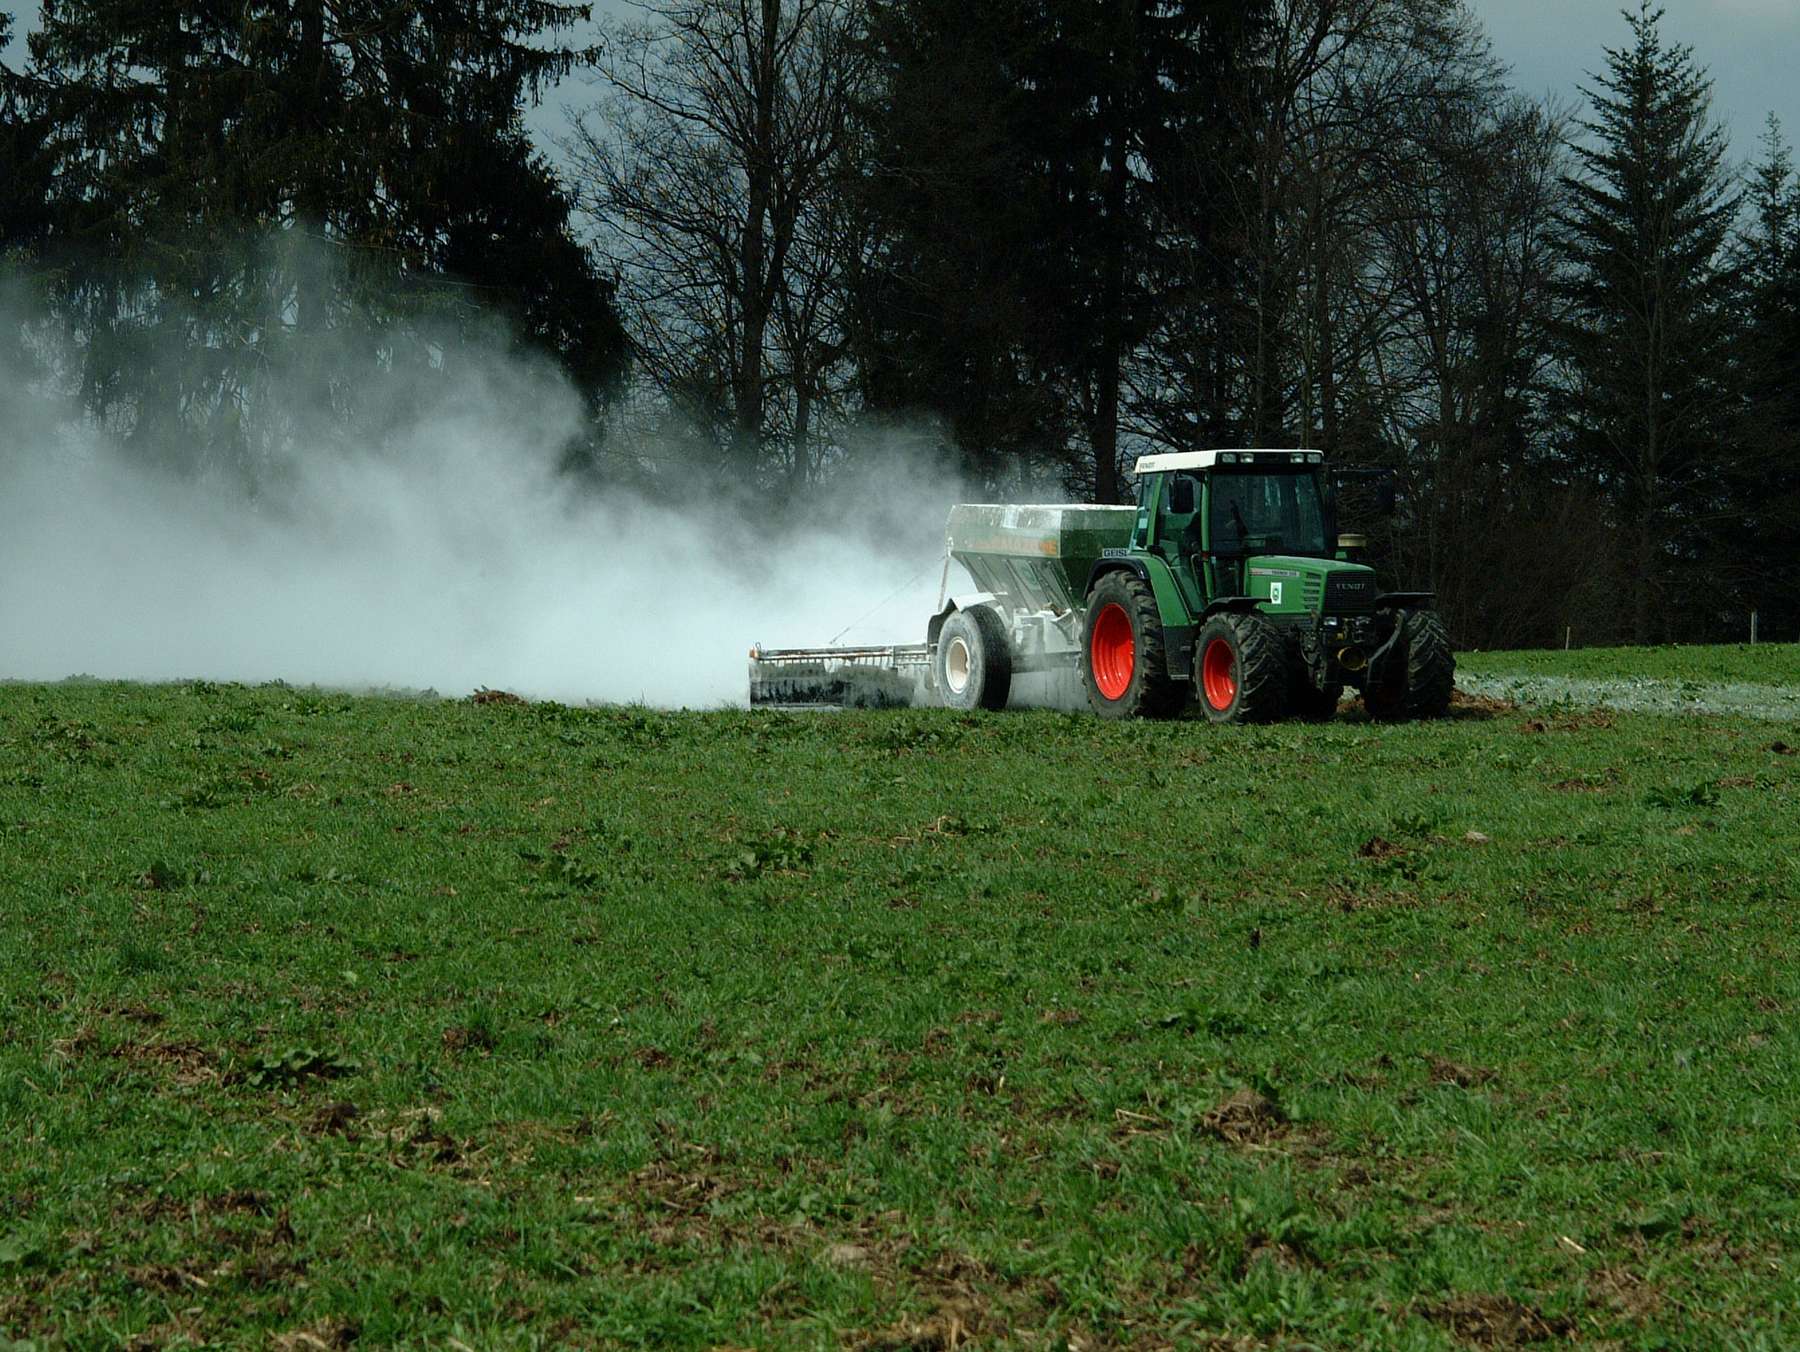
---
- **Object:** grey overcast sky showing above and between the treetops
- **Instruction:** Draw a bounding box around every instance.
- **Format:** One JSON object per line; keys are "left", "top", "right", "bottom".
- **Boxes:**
{"left": 10, "top": 0, "right": 1800, "bottom": 162}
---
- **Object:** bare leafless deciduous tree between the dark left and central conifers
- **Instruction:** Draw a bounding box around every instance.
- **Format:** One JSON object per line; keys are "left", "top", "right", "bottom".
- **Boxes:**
{"left": 569, "top": 0, "right": 860, "bottom": 477}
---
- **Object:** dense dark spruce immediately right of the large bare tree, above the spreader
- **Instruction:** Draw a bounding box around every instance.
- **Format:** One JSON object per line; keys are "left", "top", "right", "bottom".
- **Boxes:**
{"left": 851, "top": 0, "right": 1075, "bottom": 481}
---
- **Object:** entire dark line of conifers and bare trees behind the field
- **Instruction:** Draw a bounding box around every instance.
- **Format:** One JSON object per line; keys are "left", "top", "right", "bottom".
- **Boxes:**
{"left": 0, "top": 0, "right": 1800, "bottom": 646}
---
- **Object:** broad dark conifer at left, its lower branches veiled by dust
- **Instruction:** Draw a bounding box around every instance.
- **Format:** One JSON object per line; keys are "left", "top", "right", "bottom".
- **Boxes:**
{"left": 17, "top": 0, "right": 623, "bottom": 461}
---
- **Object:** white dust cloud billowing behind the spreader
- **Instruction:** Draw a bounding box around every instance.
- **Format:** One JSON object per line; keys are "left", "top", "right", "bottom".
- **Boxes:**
{"left": 0, "top": 316, "right": 956, "bottom": 708}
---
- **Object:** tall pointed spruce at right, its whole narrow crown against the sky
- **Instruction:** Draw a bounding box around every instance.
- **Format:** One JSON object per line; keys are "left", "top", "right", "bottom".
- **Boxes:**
{"left": 1561, "top": 0, "right": 1741, "bottom": 643}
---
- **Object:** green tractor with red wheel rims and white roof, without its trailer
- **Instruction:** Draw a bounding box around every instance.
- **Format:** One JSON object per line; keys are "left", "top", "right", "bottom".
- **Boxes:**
{"left": 1082, "top": 450, "right": 1456, "bottom": 722}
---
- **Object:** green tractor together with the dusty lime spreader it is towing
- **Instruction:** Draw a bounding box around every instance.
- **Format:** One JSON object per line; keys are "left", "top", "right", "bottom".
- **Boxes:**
{"left": 751, "top": 450, "right": 1456, "bottom": 722}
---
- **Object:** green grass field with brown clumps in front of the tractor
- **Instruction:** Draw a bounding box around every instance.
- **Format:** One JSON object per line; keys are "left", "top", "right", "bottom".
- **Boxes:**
{"left": 0, "top": 650, "right": 1800, "bottom": 1350}
